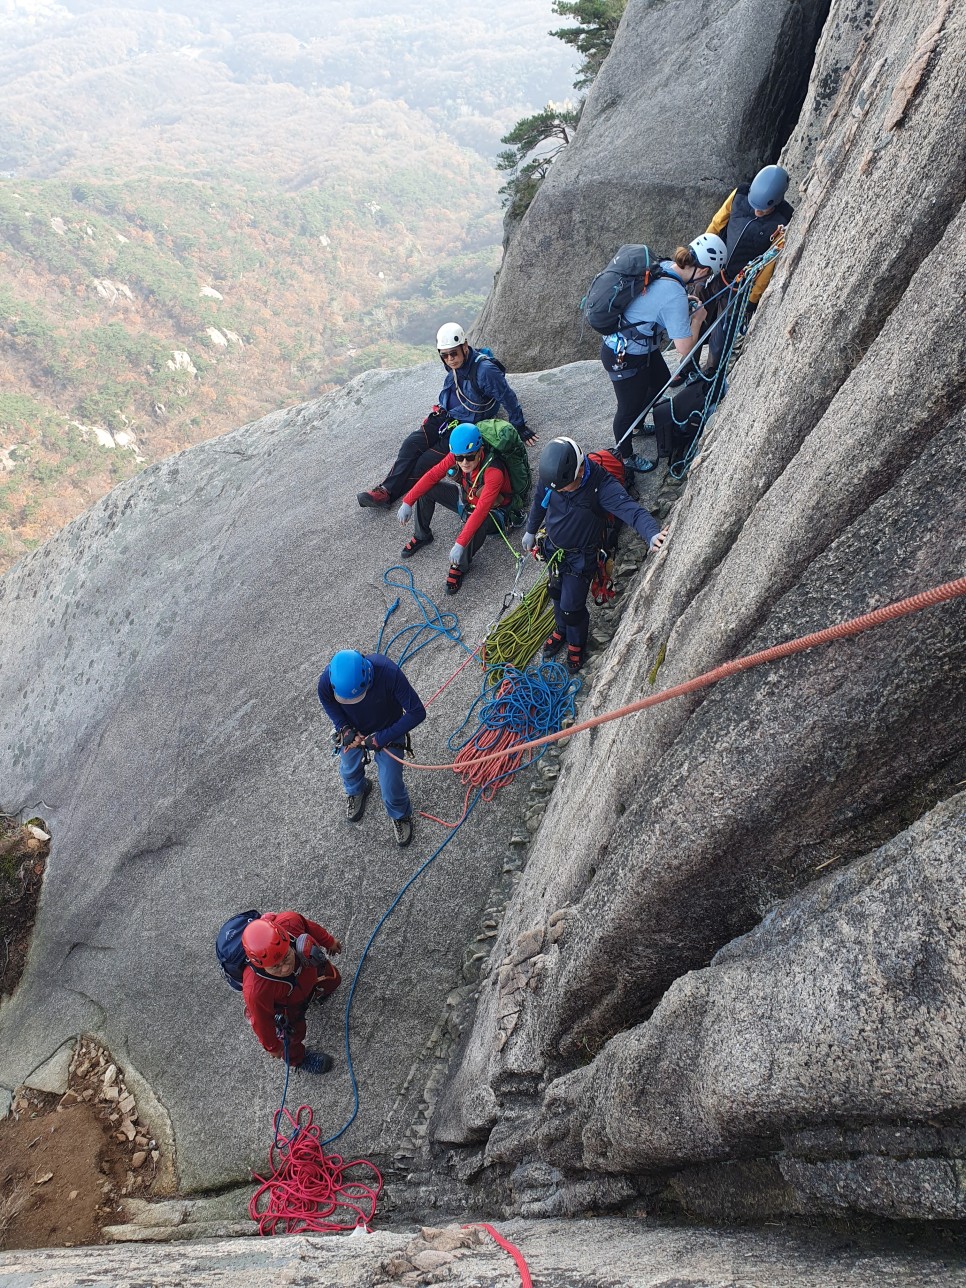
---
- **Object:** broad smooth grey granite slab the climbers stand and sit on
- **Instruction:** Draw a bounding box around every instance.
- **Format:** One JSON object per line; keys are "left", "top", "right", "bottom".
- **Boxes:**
{"left": 0, "top": 363, "right": 605, "bottom": 1189}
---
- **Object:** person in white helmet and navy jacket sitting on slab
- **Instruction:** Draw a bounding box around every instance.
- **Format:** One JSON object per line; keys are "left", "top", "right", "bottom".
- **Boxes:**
{"left": 357, "top": 322, "right": 537, "bottom": 506}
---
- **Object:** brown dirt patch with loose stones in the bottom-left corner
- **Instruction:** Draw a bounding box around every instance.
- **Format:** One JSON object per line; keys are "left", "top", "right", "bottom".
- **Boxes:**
{"left": 0, "top": 1037, "right": 160, "bottom": 1248}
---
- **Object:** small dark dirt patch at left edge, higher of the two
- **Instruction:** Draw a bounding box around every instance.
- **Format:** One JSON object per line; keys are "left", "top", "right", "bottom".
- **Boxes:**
{"left": 0, "top": 814, "right": 50, "bottom": 997}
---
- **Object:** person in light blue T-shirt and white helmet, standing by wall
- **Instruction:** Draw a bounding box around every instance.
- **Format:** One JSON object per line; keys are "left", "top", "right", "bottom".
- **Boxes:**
{"left": 600, "top": 233, "right": 725, "bottom": 474}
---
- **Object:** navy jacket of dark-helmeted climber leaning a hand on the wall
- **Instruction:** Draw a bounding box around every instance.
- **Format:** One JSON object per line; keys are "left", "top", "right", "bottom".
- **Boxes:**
{"left": 527, "top": 457, "right": 661, "bottom": 576}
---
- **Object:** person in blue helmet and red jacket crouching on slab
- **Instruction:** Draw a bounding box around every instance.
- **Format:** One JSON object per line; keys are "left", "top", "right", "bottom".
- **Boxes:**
{"left": 398, "top": 424, "right": 513, "bottom": 595}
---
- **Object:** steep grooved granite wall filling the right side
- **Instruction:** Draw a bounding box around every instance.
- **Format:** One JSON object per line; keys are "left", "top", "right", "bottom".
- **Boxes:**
{"left": 433, "top": 0, "right": 966, "bottom": 1218}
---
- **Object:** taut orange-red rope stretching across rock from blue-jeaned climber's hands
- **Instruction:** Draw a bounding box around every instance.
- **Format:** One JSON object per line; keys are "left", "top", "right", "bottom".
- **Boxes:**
{"left": 386, "top": 577, "right": 966, "bottom": 774}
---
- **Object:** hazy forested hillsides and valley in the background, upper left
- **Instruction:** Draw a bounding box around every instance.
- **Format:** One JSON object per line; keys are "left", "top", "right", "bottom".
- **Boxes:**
{"left": 0, "top": 0, "right": 573, "bottom": 569}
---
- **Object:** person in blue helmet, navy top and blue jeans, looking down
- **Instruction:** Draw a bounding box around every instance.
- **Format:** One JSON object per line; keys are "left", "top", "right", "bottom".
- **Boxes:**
{"left": 318, "top": 649, "right": 426, "bottom": 846}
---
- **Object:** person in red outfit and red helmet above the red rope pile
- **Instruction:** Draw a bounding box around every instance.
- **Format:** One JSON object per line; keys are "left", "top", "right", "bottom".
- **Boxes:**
{"left": 242, "top": 912, "right": 343, "bottom": 1073}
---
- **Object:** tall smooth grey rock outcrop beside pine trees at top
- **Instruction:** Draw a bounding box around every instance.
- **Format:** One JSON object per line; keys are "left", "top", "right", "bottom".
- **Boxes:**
{"left": 473, "top": 0, "right": 828, "bottom": 371}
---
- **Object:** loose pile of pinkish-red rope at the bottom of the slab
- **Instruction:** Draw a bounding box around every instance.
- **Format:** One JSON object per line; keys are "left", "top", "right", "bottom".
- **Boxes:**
{"left": 249, "top": 1105, "right": 383, "bottom": 1234}
